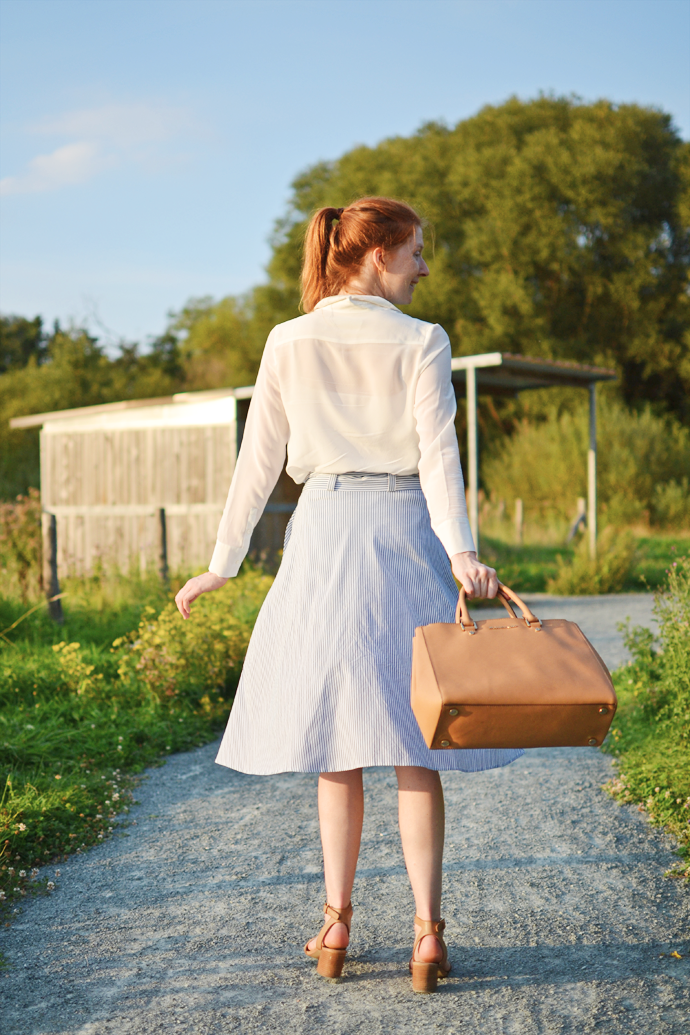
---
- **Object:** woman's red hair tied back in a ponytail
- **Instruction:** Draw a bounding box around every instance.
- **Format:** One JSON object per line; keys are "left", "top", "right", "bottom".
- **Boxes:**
{"left": 302, "top": 198, "right": 422, "bottom": 313}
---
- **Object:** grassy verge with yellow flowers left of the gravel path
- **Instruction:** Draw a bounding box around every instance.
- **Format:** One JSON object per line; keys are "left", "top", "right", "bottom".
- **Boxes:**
{"left": 0, "top": 567, "right": 271, "bottom": 922}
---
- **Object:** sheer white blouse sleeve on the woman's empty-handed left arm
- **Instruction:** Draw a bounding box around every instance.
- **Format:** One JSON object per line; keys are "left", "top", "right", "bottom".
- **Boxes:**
{"left": 209, "top": 336, "right": 290, "bottom": 579}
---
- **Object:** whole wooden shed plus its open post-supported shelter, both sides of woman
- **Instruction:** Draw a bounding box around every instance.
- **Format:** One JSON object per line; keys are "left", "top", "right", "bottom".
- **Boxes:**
{"left": 10, "top": 352, "right": 617, "bottom": 585}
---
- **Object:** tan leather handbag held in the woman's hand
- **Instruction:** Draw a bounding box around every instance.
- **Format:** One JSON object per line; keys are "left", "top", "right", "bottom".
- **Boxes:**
{"left": 412, "top": 586, "right": 618, "bottom": 750}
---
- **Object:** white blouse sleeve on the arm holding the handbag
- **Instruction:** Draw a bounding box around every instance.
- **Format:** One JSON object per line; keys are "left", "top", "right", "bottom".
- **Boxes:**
{"left": 414, "top": 325, "right": 475, "bottom": 557}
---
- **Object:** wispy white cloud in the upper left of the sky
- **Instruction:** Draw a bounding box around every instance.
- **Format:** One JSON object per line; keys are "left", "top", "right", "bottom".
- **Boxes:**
{"left": 0, "top": 104, "right": 194, "bottom": 195}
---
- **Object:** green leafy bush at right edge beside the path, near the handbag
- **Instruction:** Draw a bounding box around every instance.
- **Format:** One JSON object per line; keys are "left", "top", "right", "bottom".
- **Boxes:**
{"left": 605, "top": 557, "right": 690, "bottom": 880}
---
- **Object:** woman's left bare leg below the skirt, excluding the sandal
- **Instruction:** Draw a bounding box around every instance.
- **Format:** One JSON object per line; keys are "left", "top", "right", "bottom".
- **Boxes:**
{"left": 309, "top": 769, "right": 364, "bottom": 949}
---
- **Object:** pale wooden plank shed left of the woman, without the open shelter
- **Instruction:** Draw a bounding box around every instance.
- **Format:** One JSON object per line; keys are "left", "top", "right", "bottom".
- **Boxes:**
{"left": 11, "top": 387, "right": 299, "bottom": 575}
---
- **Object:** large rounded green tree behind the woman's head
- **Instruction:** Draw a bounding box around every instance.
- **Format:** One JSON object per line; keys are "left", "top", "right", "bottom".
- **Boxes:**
{"left": 269, "top": 96, "right": 690, "bottom": 421}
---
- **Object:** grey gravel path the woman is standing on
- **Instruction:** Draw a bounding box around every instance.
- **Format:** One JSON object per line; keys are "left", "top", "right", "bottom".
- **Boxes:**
{"left": 0, "top": 597, "right": 690, "bottom": 1035}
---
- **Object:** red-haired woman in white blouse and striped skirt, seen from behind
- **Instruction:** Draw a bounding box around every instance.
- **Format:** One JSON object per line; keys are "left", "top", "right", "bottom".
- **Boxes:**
{"left": 176, "top": 198, "right": 522, "bottom": 992}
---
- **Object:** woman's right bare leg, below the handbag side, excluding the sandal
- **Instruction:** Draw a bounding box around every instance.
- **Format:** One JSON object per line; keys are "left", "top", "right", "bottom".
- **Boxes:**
{"left": 395, "top": 766, "right": 445, "bottom": 963}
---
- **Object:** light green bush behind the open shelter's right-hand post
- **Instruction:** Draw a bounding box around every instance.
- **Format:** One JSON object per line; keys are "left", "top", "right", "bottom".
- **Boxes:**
{"left": 482, "top": 396, "right": 690, "bottom": 529}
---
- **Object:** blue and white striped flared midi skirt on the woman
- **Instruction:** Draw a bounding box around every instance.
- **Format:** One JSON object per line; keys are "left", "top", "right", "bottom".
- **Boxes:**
{"left": 216, "top": 475, "right": 522, "bottom": 775}
